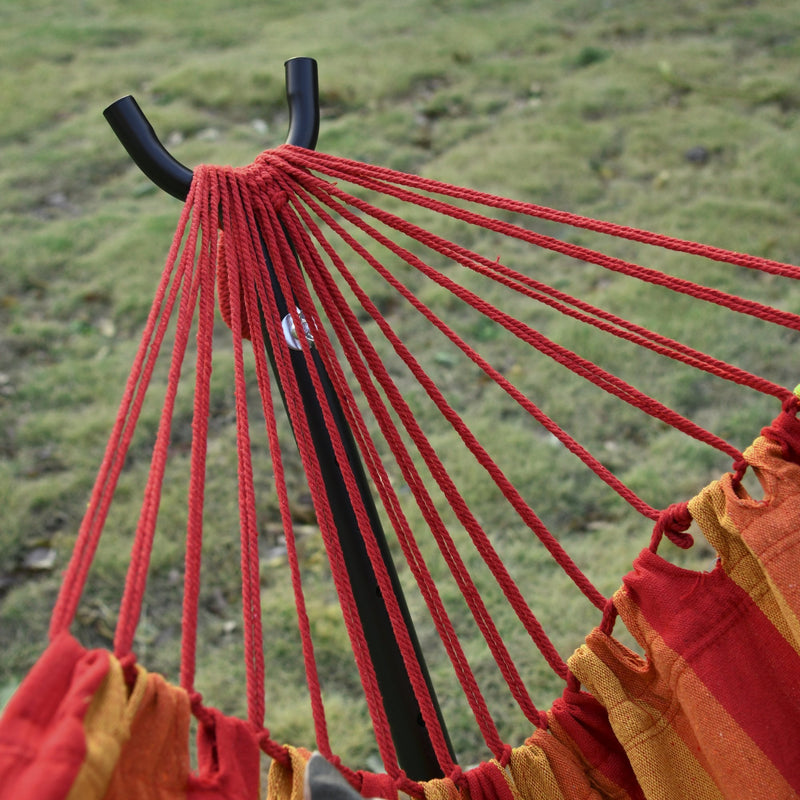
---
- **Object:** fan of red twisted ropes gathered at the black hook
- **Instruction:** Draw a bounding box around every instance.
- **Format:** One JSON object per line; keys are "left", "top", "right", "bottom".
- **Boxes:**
{"left": 51, "top": 141, "right": 800, "bottom": 784}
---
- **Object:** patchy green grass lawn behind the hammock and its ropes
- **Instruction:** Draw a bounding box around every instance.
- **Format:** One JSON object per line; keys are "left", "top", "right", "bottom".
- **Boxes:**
{"left": 0, "top": 0, "right": 800, "bottom": 766}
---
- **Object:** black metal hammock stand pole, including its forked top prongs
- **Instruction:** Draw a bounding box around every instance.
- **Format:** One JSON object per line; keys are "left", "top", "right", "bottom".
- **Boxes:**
{"left": 104, "top": 58, "right": 455, "bottom": 780}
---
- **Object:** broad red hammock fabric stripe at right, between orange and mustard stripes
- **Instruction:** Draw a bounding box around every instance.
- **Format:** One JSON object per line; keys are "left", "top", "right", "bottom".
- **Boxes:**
{"left": 624, "top": 550, "right": 800, "bottom": 791}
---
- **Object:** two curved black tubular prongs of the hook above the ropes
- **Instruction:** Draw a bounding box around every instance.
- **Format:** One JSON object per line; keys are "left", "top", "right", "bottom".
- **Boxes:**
{"left": 103, "top": 58, "right": 319, "bottom": 200}
